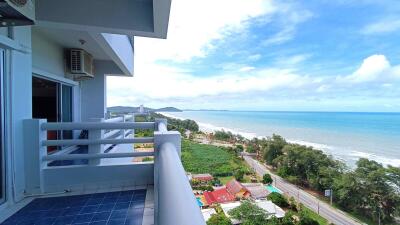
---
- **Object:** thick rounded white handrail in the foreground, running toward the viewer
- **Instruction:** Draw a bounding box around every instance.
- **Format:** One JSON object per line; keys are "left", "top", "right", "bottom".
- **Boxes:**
{"left": 154, "top": 141, "right": 206, "bottom": 225}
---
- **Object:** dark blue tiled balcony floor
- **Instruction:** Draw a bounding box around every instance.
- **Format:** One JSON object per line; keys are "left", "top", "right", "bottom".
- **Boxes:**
{"left": 2, "top": 190, "right": 146, "bottom": 225}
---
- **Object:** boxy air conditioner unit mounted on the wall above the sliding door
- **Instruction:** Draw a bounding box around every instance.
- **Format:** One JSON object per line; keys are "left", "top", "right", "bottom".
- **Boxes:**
{"left": 68, "top": 49, "right": 94, "bottom": 80}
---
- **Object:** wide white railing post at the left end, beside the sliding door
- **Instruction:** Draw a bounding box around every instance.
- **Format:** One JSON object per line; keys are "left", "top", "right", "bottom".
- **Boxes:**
{"left": 23, "top": 119, "right": 47, "bottom": 194}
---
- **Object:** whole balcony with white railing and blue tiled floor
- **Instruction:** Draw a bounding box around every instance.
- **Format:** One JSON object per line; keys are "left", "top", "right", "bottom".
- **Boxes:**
{"left": 4, "top": 116, "right": 205, "bottom": 225}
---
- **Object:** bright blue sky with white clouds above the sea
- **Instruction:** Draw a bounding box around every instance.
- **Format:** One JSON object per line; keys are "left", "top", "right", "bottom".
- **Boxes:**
{"left": 108, "top": 0, "right": 400, "bottom": 111}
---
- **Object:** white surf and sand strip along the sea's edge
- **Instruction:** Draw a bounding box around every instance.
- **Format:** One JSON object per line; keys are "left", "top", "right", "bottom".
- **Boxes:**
{"left": 159, "top": 112, "right": 400, "bottom": 167}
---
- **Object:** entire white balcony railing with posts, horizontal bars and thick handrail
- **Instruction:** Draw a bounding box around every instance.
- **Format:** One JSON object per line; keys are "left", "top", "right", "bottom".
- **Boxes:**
{"left": 24, "top": 117, "right": 205, "bottom": 225}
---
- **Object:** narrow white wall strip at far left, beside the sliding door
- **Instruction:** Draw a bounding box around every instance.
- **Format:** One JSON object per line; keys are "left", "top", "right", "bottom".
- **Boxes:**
{"left": 0, "top": 27, "right": 32, "bottom": 205}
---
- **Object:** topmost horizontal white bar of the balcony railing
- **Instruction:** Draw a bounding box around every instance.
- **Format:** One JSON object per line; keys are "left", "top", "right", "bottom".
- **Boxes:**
{"left": 41, "top": 122, "right": 155, "bottom": 130}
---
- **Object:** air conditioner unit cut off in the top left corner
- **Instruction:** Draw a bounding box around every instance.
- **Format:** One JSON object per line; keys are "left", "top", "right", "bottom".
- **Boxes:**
{"left": 0, "top": 0, "right": 35, "bottom": 27}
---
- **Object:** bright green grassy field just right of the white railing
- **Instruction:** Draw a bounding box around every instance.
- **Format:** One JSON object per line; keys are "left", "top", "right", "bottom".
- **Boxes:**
{"left": 182, "top": 140, "right": 248, "bottom": 178}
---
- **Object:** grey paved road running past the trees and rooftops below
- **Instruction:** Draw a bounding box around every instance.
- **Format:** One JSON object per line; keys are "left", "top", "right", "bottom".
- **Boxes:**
{"left": 243, "top": 156, "right": 361, "bottom": 225}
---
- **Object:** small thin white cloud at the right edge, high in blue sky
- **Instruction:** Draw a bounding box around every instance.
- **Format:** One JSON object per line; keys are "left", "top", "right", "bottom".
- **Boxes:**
{"left": 361, "top": 18, "right": 400, "bottom": 35}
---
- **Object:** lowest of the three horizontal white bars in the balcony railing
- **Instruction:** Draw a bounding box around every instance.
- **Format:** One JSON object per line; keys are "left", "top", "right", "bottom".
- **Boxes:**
{"left": 42, "top": 152, "right": 154, "bottom": 161}
